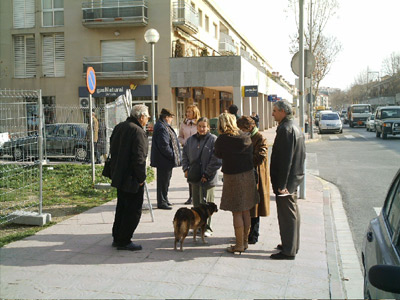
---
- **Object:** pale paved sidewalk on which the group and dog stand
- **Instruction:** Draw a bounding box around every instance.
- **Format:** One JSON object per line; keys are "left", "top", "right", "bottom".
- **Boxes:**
{"left": 0, "top": 123, "right": 363, "bottom": 299}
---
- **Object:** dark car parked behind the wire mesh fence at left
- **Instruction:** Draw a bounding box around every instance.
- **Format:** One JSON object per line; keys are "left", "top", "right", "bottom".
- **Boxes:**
{"left": 1, "top": 123, "right": 90, "bottom": 161}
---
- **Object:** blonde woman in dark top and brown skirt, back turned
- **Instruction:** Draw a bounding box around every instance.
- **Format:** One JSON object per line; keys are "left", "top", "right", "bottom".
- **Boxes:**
{"left": 215, "top": 113, "right": 259, "bottom": 253}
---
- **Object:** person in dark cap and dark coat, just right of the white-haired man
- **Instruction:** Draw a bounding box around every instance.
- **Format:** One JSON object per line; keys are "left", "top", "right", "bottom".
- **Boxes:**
{"left": 151, "top": 108, "right": 182, "bottom": 209}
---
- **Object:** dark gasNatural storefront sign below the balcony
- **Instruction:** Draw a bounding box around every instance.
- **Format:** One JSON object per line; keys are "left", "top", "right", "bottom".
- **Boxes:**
{"left": 79, "top": 84, "right": 158, "bottom": 98}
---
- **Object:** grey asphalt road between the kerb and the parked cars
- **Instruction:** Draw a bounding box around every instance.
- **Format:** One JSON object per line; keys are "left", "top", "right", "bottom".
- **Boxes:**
{"left": 307, "top": 125, "right": 400, "bottom": 257}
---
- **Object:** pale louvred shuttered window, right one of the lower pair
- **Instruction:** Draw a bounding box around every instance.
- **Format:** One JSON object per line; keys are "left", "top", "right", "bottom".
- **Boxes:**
{"left": 42, "top": 33, "right": 65, "bottom": 77}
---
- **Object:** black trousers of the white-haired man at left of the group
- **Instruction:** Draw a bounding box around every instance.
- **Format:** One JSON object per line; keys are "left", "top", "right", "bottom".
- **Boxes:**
{"left": 112, "top": 185, "right": 144, "bottom": 246}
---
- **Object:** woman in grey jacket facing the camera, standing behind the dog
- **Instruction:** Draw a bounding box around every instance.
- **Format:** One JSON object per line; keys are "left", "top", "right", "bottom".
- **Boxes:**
{"left": 182, "top": 117, "right": 222, "bottom": 236}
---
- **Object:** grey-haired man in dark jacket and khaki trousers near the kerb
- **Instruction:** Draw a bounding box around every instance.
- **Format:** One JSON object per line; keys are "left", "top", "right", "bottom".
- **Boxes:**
{"left": 270, "top": 101, "right": 306, "bottom": 259}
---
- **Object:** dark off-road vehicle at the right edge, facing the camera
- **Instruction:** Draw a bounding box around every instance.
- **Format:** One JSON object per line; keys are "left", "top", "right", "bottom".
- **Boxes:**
{"left": 375, "top": 106, "right": 400, "bottom": 140}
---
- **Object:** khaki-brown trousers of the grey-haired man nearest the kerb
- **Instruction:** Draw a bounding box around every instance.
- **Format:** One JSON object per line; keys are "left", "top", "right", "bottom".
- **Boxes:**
{"left": 275, "top": 194, "right": 300, "bottom": 256}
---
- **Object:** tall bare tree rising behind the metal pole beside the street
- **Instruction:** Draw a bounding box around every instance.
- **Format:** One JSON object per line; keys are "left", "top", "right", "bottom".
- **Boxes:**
{"left": 289, "top": 0, "right": 342, "bottom": 95}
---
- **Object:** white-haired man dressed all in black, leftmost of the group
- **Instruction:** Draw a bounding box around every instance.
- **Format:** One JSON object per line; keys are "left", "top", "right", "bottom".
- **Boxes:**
{"left": 110, "top": 104, "right": 150, "bottom": 251}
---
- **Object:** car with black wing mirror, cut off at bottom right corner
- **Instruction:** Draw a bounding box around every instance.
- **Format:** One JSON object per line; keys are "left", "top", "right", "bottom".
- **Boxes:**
{"left": 361, "top": 169, "right": 400, "bottom": 299}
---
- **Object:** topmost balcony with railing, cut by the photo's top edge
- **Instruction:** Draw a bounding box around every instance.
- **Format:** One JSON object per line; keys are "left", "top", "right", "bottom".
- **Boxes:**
{"left": 82, "top": 0, "right": 148, "bottom": 28}
